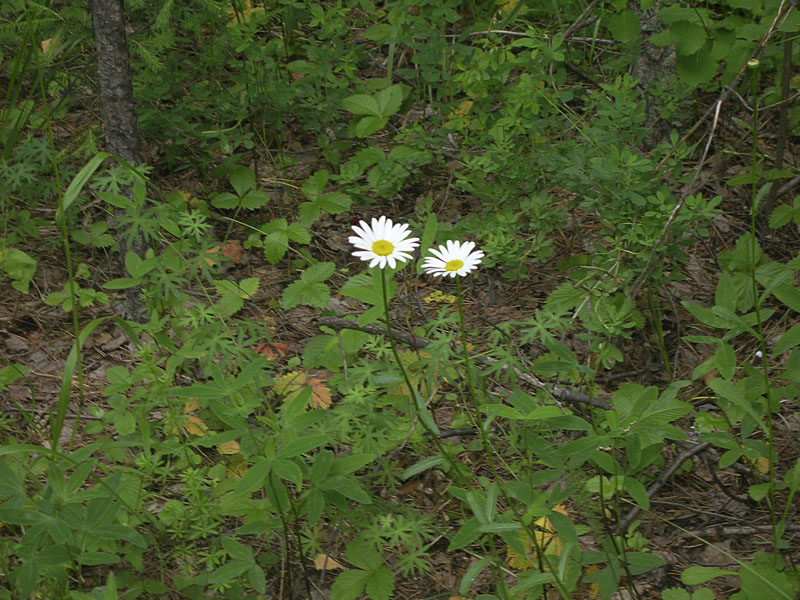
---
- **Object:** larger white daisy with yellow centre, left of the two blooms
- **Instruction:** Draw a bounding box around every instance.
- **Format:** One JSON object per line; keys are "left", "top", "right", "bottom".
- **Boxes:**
{"left": 348, "top": 217, "right": 419, "bottom": 269}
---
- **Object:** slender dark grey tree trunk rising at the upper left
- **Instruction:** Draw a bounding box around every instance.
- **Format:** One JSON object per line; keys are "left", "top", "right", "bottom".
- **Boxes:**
{"left": 90, "top": 0, "right": 147, "bottom": 323}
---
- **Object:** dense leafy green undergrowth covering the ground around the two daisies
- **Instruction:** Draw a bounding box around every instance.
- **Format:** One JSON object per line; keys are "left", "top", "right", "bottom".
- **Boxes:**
{"left": 0, "top": 0, "right": 800, "bottom": 600}
